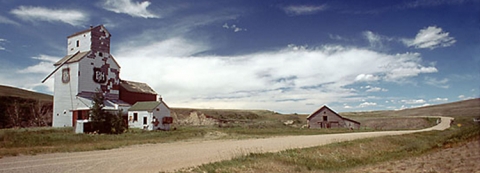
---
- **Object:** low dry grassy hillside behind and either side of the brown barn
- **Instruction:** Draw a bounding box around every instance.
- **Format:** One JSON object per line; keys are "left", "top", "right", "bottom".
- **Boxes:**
{"left": 171, "top": 99, "right": 480, "bottom": 130}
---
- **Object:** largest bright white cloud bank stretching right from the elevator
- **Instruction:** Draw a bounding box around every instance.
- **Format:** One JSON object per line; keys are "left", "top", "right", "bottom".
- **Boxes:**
{"left": 113, "top": 37, "right": 435, "bottom": 112}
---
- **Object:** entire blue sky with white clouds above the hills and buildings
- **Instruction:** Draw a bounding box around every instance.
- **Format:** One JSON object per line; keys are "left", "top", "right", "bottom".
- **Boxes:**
{"left": 0, "top": 0, "right": 480, "bottom": 113}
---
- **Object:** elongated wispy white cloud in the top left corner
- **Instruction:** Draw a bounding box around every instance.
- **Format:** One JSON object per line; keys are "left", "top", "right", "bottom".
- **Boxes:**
{"left": 10, "top": 6, "right": 88, "bottom": 26}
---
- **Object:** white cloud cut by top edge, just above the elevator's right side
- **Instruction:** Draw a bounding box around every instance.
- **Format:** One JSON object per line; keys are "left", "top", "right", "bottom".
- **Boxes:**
{"left": 103, "top": 0, "right": 160, "bottom": 18}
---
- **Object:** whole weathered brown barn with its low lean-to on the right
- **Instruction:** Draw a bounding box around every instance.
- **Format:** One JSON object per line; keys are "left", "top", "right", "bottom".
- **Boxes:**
{"left": 307, "top": 106, "right": 360, "bottom": 129}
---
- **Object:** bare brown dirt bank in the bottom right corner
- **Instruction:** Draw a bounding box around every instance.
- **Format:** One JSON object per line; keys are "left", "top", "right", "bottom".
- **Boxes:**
{"left": 348, "top": 140, "right": 480, "bottom": 173}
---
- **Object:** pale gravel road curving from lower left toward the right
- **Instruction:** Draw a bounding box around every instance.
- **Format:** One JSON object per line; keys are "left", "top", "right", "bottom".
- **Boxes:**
{"left": 0, "top": 117, "right": 450, "bottom": 172}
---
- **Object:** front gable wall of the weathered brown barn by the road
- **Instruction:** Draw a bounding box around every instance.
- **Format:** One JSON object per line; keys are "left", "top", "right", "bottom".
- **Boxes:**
{"left": 308, "top": 108, "right": 345, "bottom": 128}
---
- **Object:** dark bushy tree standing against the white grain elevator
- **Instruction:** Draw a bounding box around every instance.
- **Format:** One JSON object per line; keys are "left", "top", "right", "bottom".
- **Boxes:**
{"left": 90, "top": 90, "right": 127, "bottom": 134}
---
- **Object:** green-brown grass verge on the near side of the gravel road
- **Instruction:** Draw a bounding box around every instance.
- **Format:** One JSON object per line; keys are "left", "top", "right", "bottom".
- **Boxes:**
{"left": 185, "top": 116, "right": 480, "bottom": 172}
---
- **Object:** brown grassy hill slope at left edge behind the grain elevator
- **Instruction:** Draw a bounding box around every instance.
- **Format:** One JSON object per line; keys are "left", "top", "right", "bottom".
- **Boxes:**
{"left": 0, "top": 85, "right": 53, "bottom": 102}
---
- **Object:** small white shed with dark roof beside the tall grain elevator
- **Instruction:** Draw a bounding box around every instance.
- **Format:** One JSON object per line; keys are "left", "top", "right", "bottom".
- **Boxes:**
{"left": 128, "top": 100, "right": 173, "bottom": 130}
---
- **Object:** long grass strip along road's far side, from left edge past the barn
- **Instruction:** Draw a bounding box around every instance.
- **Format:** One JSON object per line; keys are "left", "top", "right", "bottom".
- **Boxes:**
{"left": 0, "top": 123, "right": 376, "bottom": 158}
